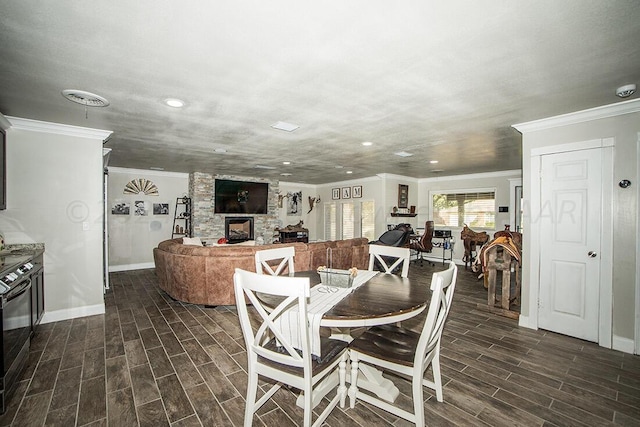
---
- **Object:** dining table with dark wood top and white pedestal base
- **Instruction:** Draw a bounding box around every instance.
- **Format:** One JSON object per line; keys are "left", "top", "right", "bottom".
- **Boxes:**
{"left": 259, "top": 271, "right": 431, "bottom": 406}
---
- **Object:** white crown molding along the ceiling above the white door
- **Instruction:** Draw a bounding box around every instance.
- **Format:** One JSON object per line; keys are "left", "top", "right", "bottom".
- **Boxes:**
{"left": 511, "top": 99, "right": 640, "bottom": 134}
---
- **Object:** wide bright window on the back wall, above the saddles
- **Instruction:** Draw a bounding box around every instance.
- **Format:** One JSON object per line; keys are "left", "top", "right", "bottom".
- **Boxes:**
{"left": 432, "top": 190, "right": 496, "bottom": 229}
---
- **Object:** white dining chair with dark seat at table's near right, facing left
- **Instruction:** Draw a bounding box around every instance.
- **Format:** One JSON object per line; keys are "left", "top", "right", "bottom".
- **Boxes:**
{"left": 349, "top": 262, "right": 458, "bottom": 427}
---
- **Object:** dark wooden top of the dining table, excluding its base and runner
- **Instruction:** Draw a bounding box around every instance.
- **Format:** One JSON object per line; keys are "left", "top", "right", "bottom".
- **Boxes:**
{"left": 261, "top": 271, "right": 431, "bottom": 327}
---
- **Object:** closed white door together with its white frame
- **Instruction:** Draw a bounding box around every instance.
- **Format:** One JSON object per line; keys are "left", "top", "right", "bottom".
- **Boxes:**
{"left": 529, "top": 138, "right": 613, "bottom": 348}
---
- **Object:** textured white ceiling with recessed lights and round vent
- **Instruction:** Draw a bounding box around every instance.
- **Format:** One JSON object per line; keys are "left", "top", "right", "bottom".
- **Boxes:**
{"left": 0, "top": 0, "right": 640, "bottom": 184}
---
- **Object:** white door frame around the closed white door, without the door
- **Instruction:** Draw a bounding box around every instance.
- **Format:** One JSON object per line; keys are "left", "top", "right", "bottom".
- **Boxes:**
{"left": 520, "top": 138, "right": 615, "bottom": 348}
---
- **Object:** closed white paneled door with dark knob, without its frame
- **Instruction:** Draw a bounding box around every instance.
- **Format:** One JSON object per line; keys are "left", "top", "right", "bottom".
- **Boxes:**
{"left": 538, "top": 149, "right": 602, "bottom": 342}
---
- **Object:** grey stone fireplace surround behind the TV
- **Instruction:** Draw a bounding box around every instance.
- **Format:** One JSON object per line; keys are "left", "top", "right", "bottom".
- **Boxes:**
{"left": 189, "top": 172, "right": 282, "bottom": 244}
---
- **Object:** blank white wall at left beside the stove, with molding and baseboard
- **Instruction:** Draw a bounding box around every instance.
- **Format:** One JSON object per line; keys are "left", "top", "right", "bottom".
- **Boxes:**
{"left": 0, "top": 117, "right": 110, "bottom": 322}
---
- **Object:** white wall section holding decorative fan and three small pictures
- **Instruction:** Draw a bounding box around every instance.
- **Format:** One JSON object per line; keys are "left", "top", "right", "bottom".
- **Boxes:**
{"left": 107, "top": 167, "right": 189, "bottom": 271}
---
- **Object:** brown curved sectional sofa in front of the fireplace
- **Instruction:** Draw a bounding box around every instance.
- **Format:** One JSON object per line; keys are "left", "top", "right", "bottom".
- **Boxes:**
{"left": 153, "top": 238, "right": 369, "bottom": 305}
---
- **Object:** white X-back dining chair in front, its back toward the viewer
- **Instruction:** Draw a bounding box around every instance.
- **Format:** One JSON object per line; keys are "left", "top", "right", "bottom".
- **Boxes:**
{"left": 233, "top": 268, "right": 348, "bottom": 427}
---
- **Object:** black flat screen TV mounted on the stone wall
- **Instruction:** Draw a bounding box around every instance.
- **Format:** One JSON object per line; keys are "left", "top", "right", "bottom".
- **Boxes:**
{"left": 214, "top": 179, "right": 269, "bottom": 214}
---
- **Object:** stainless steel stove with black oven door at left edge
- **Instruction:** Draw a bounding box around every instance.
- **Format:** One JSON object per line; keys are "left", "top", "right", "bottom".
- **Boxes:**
{"left": 0, "top": 255, "right": 35, "bottom": 413}
